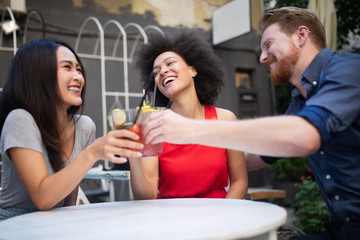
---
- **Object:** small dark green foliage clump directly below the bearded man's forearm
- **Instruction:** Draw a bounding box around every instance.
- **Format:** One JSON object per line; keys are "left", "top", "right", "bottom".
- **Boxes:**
{"left": 268, "top": 157, "right": 311, "bottom": 183}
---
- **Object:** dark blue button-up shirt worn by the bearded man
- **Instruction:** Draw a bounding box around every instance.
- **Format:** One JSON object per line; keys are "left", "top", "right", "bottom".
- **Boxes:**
{"left": 263, "top": 48, "right": 360, "bottom": 228}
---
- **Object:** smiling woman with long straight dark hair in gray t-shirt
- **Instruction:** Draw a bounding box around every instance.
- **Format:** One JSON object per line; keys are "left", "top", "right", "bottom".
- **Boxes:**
{"left": 0, "top": 40, "right": 142, "bottom": 220}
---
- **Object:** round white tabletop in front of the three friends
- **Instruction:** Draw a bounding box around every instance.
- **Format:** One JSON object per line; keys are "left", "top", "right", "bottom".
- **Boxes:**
{"left": 0, "top": 198, "right": 286, "bottom": 240}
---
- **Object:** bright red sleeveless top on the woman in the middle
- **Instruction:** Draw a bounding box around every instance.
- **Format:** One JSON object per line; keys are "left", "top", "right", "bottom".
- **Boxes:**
{"left": 158, "top": 105, "right": 229, "bottom": 198}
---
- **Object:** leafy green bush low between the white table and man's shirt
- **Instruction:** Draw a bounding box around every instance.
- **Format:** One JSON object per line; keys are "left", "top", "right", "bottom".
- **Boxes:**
{"left": 292, "top": 176, "right": 330, "bottom": 233}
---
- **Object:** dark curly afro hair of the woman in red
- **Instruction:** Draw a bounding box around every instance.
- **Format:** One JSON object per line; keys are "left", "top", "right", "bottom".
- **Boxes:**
{"left": 136, "top": 31, "right": 224, "bottom": 106}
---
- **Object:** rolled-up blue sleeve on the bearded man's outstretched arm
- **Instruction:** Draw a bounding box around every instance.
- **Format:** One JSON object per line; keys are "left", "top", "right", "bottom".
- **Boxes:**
{"left": 297, "top": 54, "right": 360, "bottom": 143}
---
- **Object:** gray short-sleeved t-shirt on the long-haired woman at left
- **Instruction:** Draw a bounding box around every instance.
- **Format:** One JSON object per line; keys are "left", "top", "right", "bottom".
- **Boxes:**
{"left": 0, "top": 109, "right": 95, "bottom": 211}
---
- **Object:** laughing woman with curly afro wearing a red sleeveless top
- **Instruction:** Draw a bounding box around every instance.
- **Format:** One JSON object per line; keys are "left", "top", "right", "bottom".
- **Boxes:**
{"left": 130, "top": 31, "right": 248, "bottom": 199}
